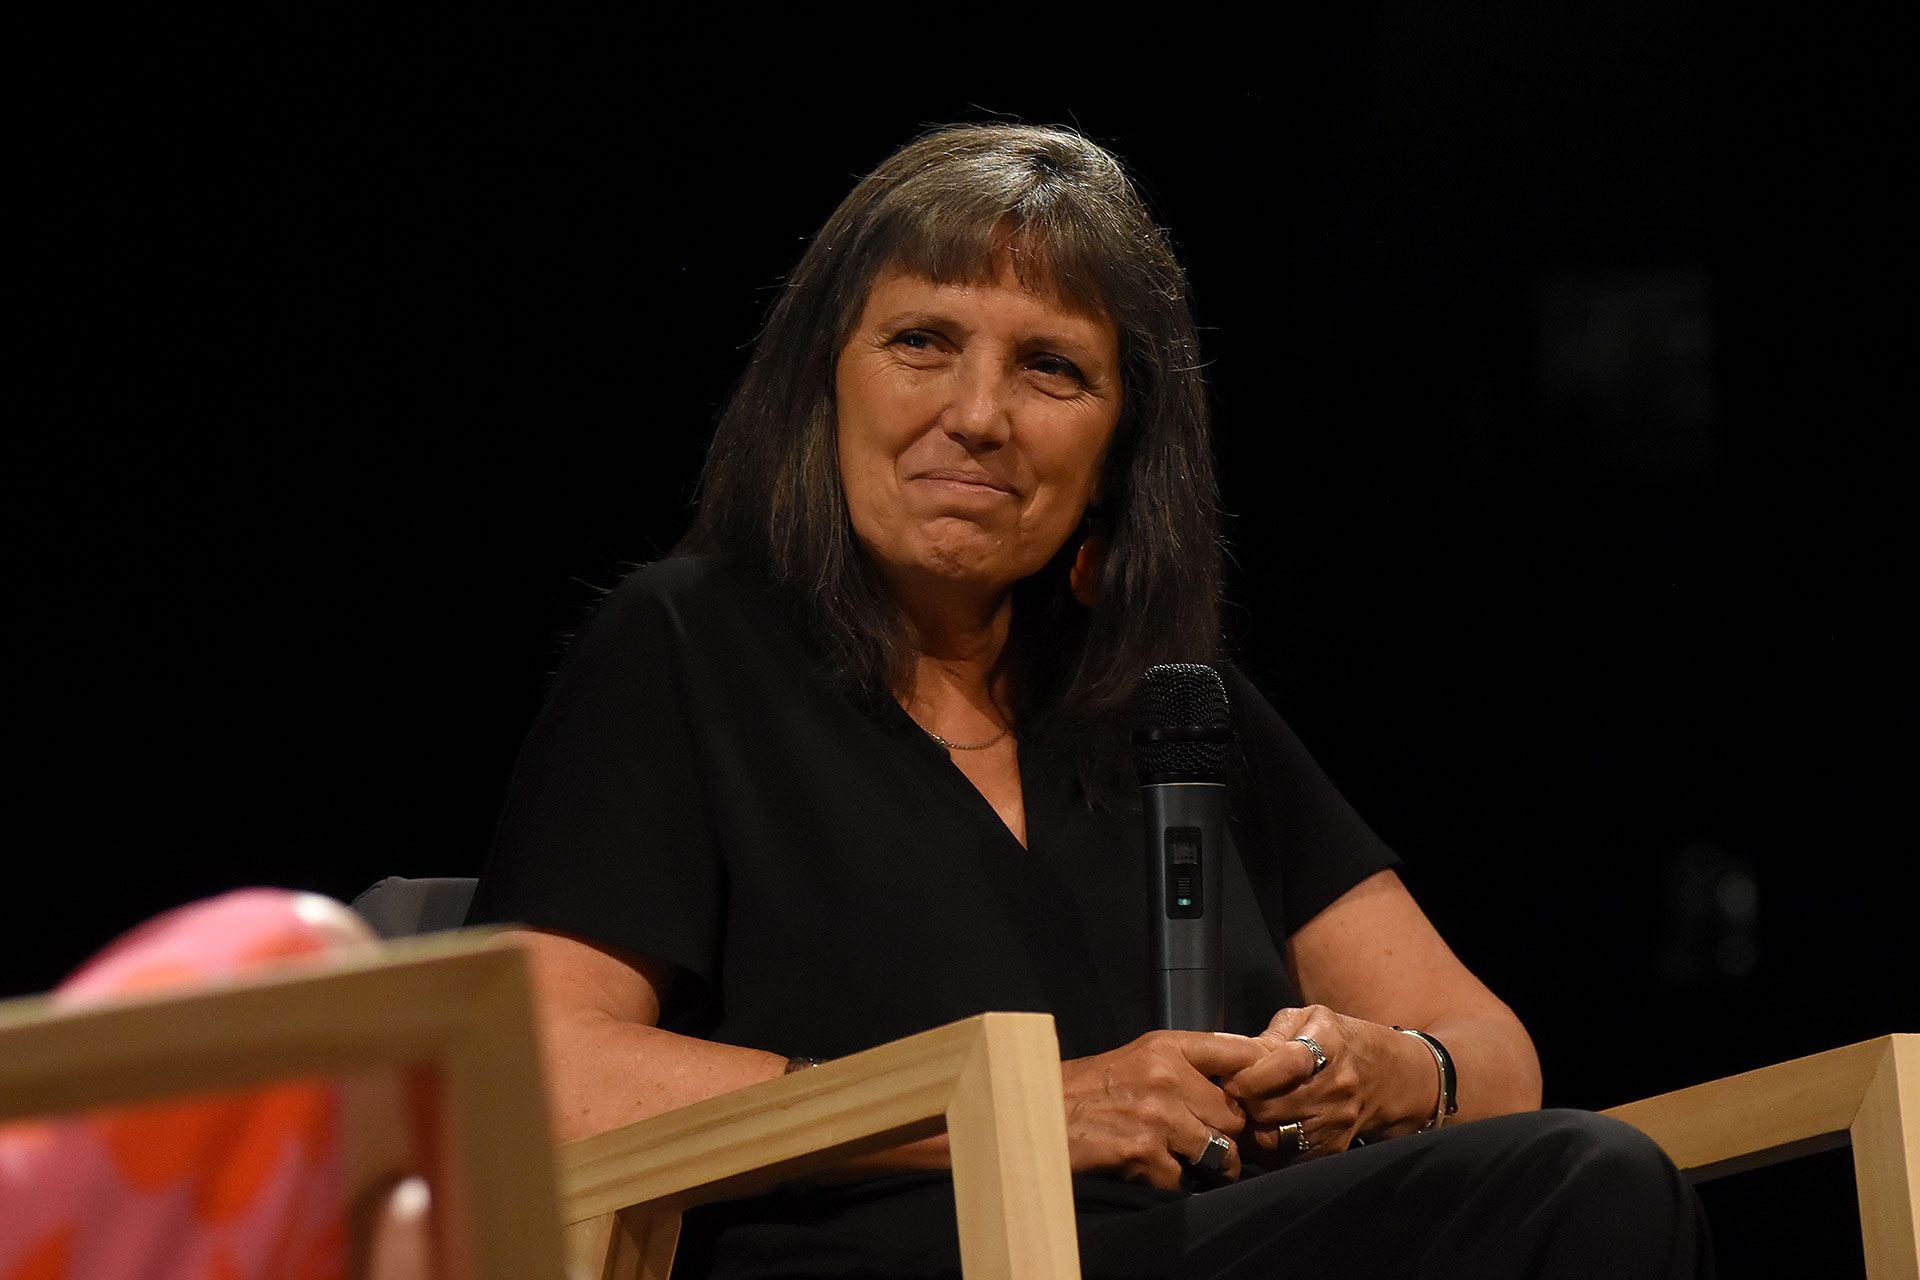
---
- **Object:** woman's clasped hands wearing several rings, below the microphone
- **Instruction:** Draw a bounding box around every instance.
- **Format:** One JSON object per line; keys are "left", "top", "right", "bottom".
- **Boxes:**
{"left": 1062, "top": 1006, "right": 1398, "bottom": 1190}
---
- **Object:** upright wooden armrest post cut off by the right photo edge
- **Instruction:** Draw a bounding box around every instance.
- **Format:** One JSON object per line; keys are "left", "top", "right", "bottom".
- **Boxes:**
{"left": 1853, "top": 1036, "right": 1920, "bottom": 1280}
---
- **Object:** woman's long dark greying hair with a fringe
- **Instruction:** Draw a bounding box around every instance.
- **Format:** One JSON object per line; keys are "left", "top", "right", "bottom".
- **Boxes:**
{"left": 674, "top": 125, "right": 1223, "bottom": 804}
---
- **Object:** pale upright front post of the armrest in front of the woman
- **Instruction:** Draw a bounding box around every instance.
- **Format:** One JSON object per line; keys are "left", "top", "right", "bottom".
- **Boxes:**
{"left": 947, "top": 1015, "right": 1079, "bottom": 1280}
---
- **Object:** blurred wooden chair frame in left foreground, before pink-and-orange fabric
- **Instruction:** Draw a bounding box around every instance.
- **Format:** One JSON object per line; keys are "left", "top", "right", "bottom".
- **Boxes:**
{"left": 0, "top": 933, "right": 563, "bottom": 1280}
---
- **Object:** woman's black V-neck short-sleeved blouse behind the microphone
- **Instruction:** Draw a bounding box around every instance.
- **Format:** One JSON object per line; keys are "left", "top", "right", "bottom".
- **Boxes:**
{"left": 468, "top": 558, "right": 1400, "bottom": 1057}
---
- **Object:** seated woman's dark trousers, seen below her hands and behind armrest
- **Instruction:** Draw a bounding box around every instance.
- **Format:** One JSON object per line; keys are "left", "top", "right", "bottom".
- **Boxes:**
{"left": 676, "top": 1111, "right": 1713, "bottom": 1280}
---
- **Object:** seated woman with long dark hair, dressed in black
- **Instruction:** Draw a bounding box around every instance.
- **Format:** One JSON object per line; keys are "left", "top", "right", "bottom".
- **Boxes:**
{"left": 472, "top": 125, "right": 1707, "bottom": 1276}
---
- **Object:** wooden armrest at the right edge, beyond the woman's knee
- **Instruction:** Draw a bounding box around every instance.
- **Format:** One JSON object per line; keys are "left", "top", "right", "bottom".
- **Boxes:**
{"left": 1603, "top": 1034, "right": 1920, "bottom": 1280}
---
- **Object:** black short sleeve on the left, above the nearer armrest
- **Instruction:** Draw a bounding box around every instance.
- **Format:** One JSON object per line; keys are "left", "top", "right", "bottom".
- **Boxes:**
{"left": 467, "top": 570, "right": 724, "bottom": 983}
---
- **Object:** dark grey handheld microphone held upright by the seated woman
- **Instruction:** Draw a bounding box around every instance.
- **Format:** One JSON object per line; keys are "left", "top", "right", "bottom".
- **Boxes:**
{"left": 1133, "top": 662, "right": 1233, "bottom": 1031}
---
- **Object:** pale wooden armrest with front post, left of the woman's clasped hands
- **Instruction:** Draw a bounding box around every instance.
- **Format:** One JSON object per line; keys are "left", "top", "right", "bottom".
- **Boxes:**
{"left": 559, "top": 1013, "right": 1079, "bottom": 1276}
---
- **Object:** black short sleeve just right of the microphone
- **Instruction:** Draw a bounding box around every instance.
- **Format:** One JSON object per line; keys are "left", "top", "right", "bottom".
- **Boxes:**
{"left": 1223, "top": 666, "right": 1400, "bottom": 942}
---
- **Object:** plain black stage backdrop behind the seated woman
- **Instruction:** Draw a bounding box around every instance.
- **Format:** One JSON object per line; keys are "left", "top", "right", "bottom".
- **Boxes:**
{"left": 18, "top": 2, "right": 1920, "bottom": 1274}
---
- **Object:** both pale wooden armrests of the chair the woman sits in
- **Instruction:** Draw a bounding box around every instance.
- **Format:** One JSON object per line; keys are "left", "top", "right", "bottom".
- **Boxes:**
{"left": 561, "top": 1013, "right": 1920, "bottom": 1280}
